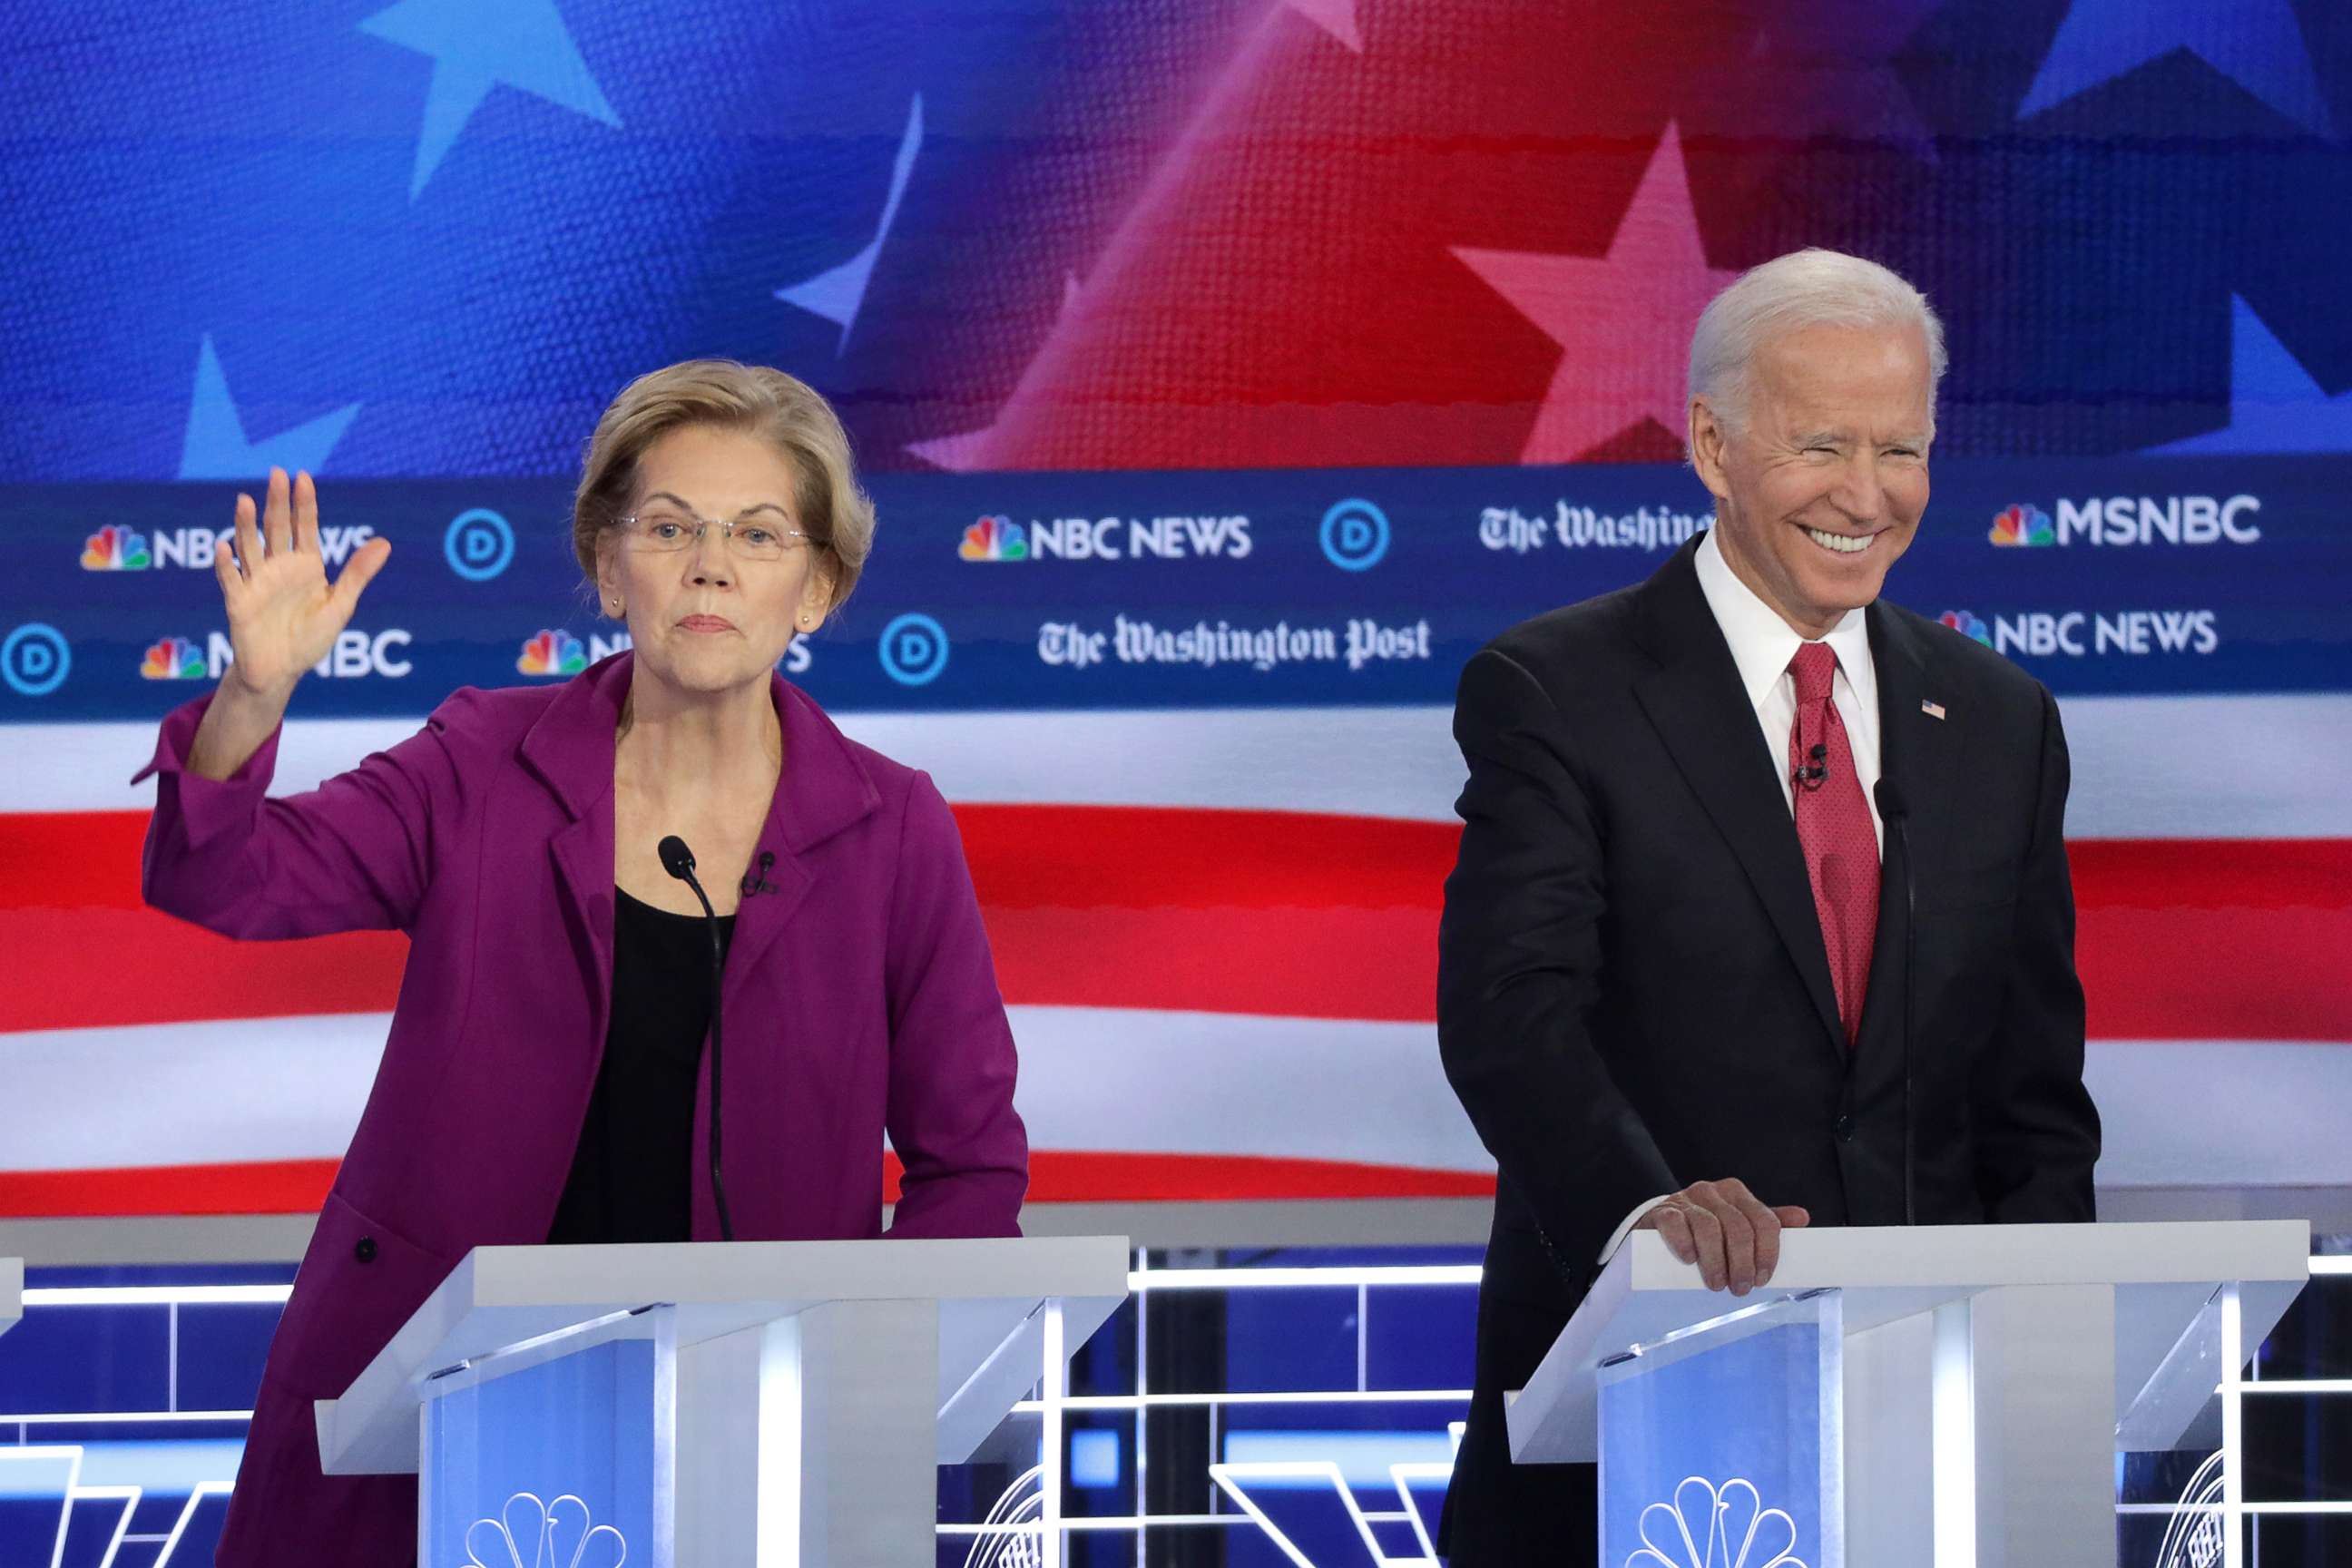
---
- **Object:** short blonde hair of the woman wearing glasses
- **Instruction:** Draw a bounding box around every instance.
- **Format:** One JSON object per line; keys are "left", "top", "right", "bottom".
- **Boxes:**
{"left": 572, "top": 359, "right": 875, "bottom": 609}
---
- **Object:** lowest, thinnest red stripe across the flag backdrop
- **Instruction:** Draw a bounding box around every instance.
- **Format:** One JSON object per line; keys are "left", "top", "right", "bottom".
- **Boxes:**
{"left": 0, "top": 1150, "right": 1494, "bottom": 1220}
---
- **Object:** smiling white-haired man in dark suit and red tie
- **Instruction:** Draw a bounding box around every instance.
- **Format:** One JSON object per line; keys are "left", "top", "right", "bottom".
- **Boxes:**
{"left": 1437, "top": 251, "right": 2098, "bottom": 1568}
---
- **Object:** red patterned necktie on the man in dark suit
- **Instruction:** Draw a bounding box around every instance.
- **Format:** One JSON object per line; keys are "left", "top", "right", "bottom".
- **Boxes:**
{"left": 1788, "top": 642, "right": 1879, "bottom": 1046}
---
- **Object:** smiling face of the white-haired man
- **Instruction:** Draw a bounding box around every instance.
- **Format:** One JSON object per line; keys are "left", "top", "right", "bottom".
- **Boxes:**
{"left": 1691, "top": 327, "right": 1931, "bottom": 637}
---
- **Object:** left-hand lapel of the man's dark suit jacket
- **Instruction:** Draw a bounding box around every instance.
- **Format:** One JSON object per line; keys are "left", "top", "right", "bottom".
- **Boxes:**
{"left": 1634, "top": 545, "right": 1847, "bottom": 1060}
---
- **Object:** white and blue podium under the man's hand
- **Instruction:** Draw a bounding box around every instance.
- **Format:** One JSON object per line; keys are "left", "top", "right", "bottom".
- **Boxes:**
{"left": 1505, "top": 1220, "right": 2309, "bottom": 1568}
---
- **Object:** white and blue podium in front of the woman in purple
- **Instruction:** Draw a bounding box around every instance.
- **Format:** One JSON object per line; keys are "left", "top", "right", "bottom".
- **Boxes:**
{"left": 318, "top": 1237, "right": 1127, "bottom": 1568}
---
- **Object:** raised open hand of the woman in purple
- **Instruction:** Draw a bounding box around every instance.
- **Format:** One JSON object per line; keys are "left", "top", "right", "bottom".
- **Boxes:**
{"left": 211, "top": 468, "right": 393, "bottom": 698}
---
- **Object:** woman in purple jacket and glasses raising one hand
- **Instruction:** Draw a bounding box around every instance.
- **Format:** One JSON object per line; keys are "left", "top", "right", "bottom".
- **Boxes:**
{"left": 142, "top": 359, "right": 1028, "bottom": 1568}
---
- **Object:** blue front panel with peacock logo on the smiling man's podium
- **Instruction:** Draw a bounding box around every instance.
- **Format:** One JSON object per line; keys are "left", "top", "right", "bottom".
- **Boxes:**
{"left": 1600, "top": 1290, "right": 1844, "bottom": 1568}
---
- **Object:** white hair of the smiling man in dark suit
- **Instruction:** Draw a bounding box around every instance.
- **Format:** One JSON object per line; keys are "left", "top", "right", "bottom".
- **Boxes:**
{"left": 1691, "top": 247, "right": 1945, "bottom": 446}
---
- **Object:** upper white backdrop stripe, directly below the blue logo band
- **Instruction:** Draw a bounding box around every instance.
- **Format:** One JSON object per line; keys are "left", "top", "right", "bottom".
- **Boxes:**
{"left": 0, "top": 693, "right": 2352, "bottom": 839}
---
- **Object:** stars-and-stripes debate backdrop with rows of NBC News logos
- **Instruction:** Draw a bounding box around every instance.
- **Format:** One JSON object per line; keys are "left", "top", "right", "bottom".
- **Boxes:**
{"left": 0, "top": 0, "right": 2352, "bottom": 1215}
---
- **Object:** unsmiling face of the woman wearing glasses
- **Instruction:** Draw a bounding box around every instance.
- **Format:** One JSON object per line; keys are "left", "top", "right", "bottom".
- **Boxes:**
{"left": 597, "top": 426, "right": 830, "bottom": 691}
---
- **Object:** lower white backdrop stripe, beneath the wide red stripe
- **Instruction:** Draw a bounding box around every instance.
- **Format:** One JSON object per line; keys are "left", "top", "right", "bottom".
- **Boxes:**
{"left": 0, "top": 1006, "right": 2352, "bottom": 1187}
